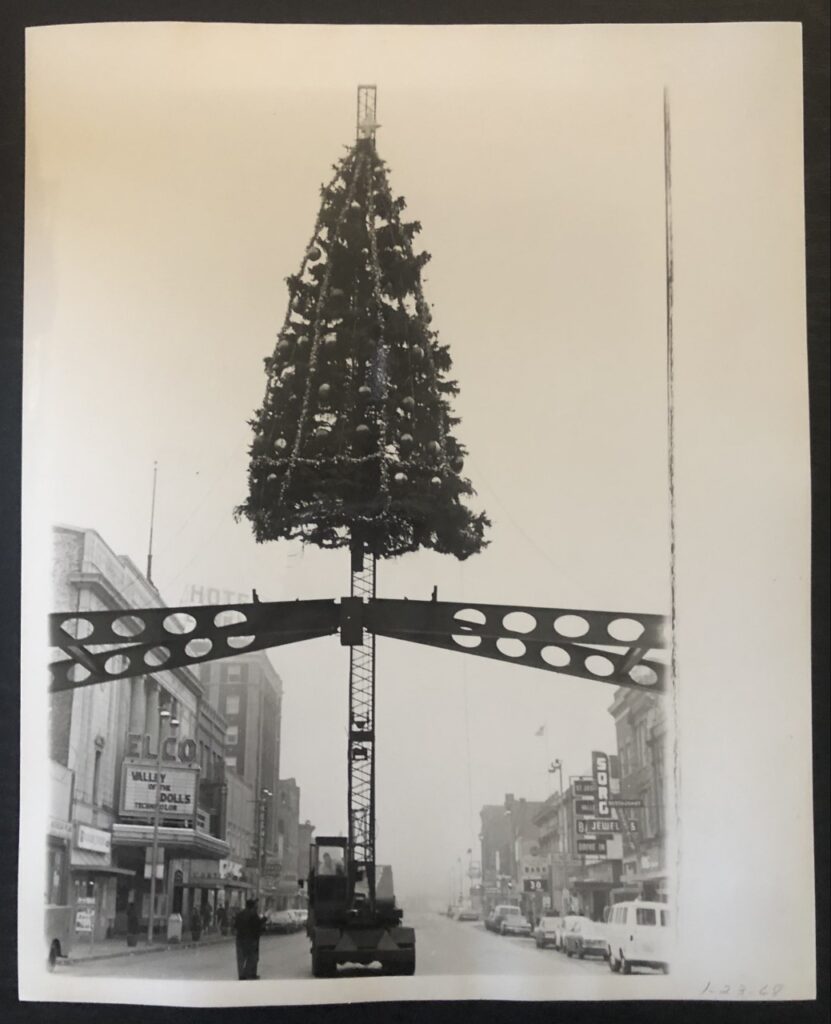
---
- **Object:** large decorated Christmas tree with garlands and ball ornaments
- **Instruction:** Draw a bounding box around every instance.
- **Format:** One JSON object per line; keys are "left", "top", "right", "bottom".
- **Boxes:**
{"left": 235, "top": 138, "right": 490, "bottom": 558}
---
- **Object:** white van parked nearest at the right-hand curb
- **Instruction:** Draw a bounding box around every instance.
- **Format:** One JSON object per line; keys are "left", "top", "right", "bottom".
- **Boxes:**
{"left": 605, "top": 900, "right": 673, "bottom": 974}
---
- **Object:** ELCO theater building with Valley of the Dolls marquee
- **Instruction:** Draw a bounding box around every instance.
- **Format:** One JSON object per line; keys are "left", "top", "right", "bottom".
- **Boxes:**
{"left": 49, "top": 526, "right": 228, "bottom": 941}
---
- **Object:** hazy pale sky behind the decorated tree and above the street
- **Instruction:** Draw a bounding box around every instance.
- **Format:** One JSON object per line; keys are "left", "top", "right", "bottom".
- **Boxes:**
{"left": 26, "top": 25, "right": 790, "bottom": 895}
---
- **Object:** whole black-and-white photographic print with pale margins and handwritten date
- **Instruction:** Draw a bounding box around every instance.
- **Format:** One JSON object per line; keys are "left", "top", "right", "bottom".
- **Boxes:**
{"left": 18, "top": 22, "right": 815, "bottom": 1006}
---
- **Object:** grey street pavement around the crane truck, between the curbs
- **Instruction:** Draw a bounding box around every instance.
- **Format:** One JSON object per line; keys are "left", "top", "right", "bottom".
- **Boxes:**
{"left": 63, "top": 913, "right": 609, "bottom": 981}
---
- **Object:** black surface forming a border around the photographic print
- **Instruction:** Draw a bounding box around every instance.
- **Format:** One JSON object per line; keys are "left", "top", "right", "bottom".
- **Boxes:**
{"left": 0, "top": 0, "right": 831, "bottom": 1024}
